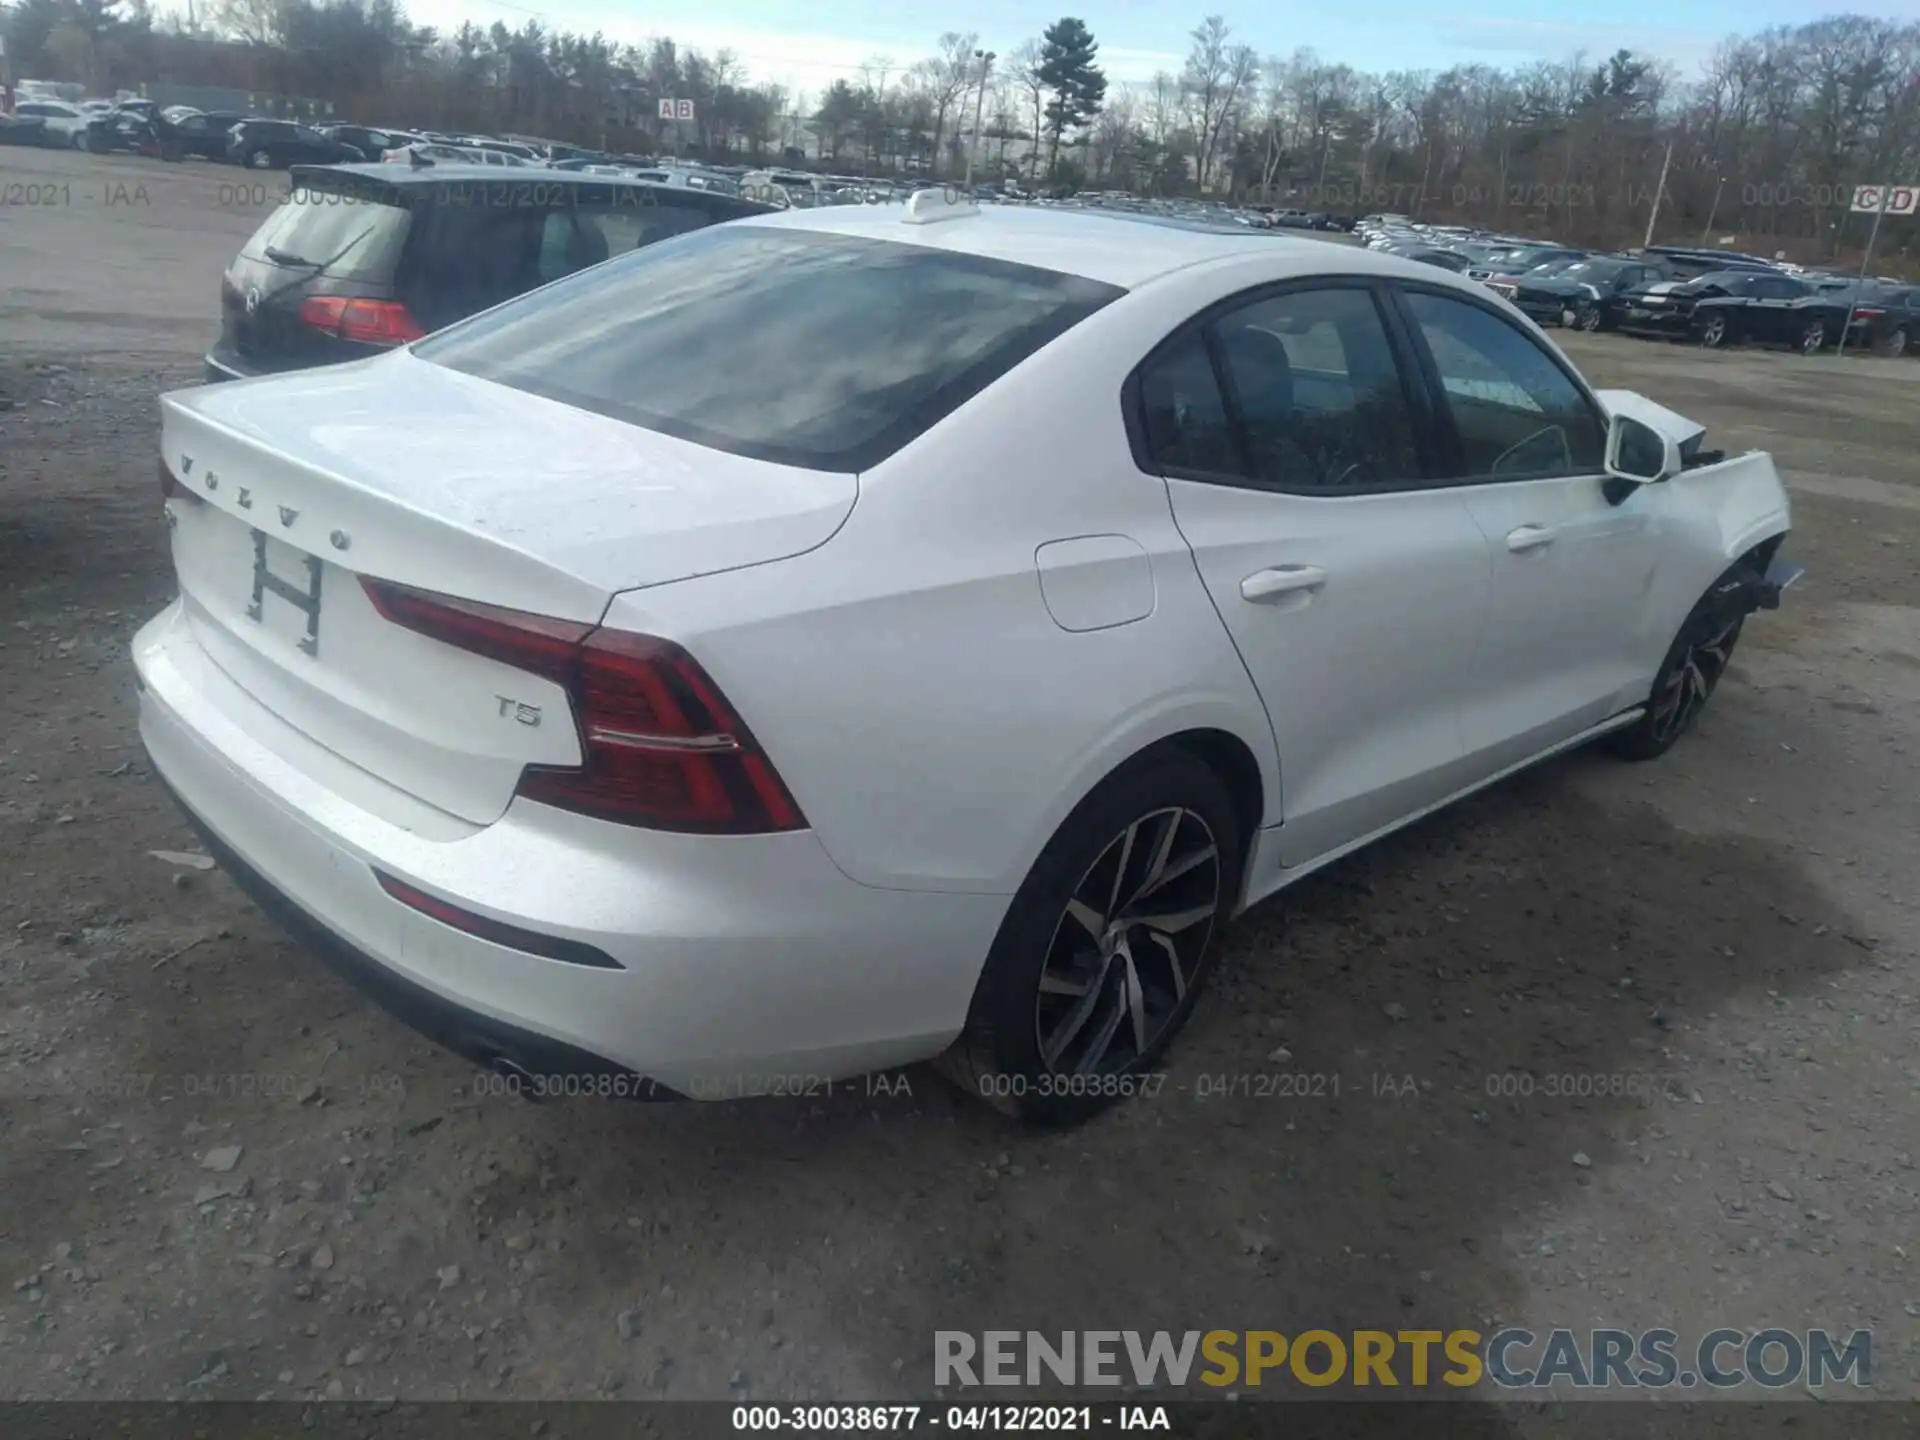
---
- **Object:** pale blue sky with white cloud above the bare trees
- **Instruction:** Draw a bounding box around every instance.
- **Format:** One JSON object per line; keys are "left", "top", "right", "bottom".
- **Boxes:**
{"left": 382, "top": 0, "right": 1920, "bottom": 94}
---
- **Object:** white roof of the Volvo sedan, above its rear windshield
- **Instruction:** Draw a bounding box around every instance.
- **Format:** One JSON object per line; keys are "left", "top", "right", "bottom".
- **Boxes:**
{"left": 741, "top": 203, "right": 1432, "bottom": 290}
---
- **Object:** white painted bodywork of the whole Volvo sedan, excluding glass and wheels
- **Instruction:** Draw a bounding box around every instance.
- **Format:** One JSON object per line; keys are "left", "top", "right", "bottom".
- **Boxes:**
{"left": 134, "top": 207, "right": 1788, "bottom": 1089}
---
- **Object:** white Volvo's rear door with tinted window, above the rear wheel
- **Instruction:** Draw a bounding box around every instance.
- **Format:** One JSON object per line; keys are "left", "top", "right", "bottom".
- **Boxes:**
{"left": 1140, "top": 280, "right": 1488, "bottom": 868}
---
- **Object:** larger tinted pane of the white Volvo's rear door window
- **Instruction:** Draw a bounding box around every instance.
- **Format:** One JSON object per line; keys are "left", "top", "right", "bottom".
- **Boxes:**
{"left": 1215, "top": 290, "right": 1419, "bottom": 490}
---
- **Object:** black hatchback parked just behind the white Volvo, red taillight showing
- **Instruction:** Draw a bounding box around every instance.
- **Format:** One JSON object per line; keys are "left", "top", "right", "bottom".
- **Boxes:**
{"left": 205, "top": 163, "right": 774, "bottom": 380}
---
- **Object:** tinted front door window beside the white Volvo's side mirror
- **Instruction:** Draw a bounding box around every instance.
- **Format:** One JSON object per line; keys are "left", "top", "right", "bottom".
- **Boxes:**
{"left": 1407, "top": 294, "right": 1605, "bottom": 480}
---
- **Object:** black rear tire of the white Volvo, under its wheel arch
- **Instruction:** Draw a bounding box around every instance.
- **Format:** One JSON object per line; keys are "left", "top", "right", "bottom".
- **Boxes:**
{"left": 937, "top": 747, "right": 1242, "bottom": 1125}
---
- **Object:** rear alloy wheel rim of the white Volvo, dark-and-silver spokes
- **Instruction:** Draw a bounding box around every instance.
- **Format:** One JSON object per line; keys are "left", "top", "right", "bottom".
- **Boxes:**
{"left": 1033, "top": 806, "right": 1223, "bottom": 1075}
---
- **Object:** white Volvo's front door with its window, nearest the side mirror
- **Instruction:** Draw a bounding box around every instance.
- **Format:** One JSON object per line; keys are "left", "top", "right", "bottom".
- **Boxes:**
{"left": 1398, "top": 284, "right": 1659, "bottom": 774}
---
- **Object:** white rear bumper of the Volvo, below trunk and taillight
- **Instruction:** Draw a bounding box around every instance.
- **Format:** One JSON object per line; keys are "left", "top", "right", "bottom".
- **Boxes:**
{"left": 132, "top": 603, "right": 1008, "bottom": 1098}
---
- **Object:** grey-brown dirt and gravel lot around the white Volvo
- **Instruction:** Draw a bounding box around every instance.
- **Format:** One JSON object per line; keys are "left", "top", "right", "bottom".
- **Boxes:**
{"left": 0, "top": 152, "right": 1920, "bottom": 1432}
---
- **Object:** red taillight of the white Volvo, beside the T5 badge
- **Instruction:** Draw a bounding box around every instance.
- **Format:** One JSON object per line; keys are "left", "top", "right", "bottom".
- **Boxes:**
{"left": 361, "top": 576, "right": 806, "bottom": 835}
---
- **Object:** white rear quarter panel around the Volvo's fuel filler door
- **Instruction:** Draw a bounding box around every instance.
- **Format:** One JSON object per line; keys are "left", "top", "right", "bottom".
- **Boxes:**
{"left": 607, "top": 268, "right": 1281, "bottom": 895}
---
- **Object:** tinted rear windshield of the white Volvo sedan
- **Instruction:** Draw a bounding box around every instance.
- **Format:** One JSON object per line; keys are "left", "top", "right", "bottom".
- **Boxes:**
{"left": 415, "top": 223, "right": 1123, "bottom": 470}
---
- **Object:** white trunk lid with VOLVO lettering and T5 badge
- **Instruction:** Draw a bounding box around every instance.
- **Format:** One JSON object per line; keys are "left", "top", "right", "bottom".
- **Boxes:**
{"left": 161, "top": 351, "right": 858, "bottom": 824}
